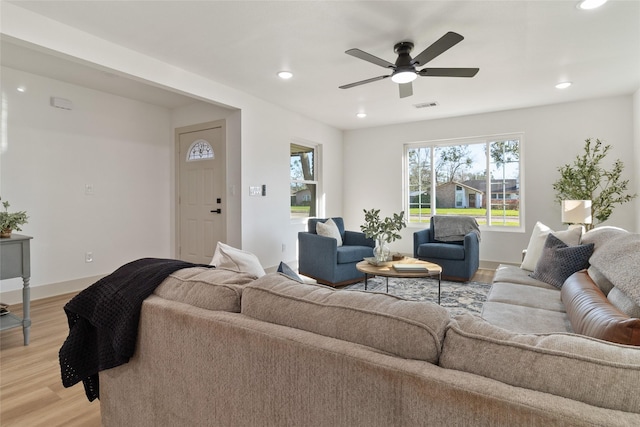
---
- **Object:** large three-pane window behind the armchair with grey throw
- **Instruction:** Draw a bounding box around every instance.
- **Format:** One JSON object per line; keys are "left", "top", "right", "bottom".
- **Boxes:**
{"left": 405, "top": 134, "right": 523, "bottom": 229}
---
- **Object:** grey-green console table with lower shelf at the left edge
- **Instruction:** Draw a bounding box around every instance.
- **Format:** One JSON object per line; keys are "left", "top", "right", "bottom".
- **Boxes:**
{"left": 0, "top": 234, "right": 32, "bottom": 345}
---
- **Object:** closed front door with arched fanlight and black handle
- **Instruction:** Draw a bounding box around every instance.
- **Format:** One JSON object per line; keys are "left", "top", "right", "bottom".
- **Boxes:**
{"left": 176, "top": 122, "right": 226, "bottom": 264}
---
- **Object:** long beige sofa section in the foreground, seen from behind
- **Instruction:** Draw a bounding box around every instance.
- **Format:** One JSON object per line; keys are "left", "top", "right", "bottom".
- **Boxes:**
{"left": 100, "top": 242, "right": 640, "bottom": 427}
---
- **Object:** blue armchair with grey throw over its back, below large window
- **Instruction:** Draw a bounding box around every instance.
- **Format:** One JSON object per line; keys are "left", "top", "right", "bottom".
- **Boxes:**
{"left": 413, "top": 216, "right": 480, "bottom": 282}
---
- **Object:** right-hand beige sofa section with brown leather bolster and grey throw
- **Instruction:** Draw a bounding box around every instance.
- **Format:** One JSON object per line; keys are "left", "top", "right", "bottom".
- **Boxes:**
{"left": 482, "top": 226, "right": 640, "bottom": 351}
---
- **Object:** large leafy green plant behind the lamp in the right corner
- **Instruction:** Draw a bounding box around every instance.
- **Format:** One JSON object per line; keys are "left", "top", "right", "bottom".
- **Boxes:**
{"left": 553, "top": 138, "right": 637, "bottom": 229}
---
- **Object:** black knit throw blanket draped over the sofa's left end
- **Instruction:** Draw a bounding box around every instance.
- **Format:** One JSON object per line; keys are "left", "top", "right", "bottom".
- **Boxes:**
{"left": 59, "top": 258, "right": 206, "bottom": 401}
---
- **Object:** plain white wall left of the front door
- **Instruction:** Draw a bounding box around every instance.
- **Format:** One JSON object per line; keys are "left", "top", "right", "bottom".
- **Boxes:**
{"left": 0, "top": 67, "right": 173, "bottom": 296}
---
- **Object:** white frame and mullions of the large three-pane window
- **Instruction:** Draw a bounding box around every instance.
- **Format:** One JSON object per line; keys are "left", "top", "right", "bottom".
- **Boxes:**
{"left": 402, "top": 132, "right": 525, "bottom": 233}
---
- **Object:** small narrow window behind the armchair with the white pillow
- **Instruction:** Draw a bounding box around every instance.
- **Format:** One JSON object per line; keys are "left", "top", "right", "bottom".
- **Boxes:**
{"left": 290, "top": 143, "right": 318, "bottom": 218}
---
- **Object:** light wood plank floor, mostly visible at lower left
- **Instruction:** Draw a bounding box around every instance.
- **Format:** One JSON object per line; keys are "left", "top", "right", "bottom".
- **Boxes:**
{"left": 0, "top": 269, "right": 494, "bottom": 427}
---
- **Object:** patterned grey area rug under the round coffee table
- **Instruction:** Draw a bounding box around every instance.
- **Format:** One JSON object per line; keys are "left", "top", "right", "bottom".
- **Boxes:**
{"left": 343, "top": 277, "right": 491, "bottom": 316}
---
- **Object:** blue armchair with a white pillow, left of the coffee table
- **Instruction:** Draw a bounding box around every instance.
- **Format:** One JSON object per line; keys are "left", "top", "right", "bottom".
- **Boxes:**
{"left": 298, "top": 217, "right": 375, "bottom": 286}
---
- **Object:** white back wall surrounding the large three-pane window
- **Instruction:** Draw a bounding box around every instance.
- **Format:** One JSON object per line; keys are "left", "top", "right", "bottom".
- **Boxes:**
{"left": 344, "top": 96, "right": 639, "bottom": 263}
